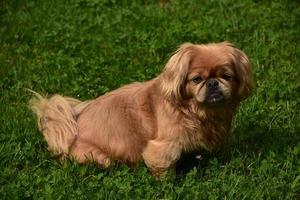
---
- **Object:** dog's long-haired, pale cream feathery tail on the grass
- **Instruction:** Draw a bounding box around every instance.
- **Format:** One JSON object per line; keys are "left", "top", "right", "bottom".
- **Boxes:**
{"left": 29, "top": 90, "right": 90, "bottom": 157}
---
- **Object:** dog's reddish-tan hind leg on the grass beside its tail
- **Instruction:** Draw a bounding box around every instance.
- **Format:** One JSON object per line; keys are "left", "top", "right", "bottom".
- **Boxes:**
{"left": 69, "top": 138, "right": 111, "bottom": 168}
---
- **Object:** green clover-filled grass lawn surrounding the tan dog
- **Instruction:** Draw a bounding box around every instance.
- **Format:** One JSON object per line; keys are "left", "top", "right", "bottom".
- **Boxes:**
{"left": 0, "top": 0, "right": 300, "bottom": 199}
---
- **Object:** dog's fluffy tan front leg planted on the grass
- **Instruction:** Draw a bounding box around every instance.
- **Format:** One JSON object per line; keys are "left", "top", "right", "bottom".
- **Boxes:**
{"left": 143, "top": 140, "right": 181, "bottom": 177}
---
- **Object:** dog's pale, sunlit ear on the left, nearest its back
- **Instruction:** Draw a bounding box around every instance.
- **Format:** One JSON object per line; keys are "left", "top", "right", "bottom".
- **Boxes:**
{"left": 160, "top": 43, "right": 195, "bottom": 105}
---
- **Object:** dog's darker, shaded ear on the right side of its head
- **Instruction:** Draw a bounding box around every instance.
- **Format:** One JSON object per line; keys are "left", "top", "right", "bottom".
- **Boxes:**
{"left": 231, "top": 45, "right": 254, "bottom": 99}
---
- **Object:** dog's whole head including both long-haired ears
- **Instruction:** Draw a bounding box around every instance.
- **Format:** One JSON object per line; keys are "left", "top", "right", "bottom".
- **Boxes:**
{"left": 162, "top": 42, "right": 253, "bottom": 106}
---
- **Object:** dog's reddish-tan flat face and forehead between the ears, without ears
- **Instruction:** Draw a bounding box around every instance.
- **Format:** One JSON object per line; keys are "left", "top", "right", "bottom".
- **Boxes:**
{"left": 186, "top": 45, "right": 238, "bottom": 104}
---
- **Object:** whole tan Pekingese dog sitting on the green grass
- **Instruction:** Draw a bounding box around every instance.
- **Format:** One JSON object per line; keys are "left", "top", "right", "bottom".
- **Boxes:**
{"left": 31, "top": 42, "right": 253, "bottom": 176}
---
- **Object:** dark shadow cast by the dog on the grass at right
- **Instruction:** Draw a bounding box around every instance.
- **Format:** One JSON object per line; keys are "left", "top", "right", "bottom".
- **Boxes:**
{"left": 176, "top": 127, "right": 300, "bottom": 176}
